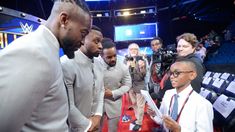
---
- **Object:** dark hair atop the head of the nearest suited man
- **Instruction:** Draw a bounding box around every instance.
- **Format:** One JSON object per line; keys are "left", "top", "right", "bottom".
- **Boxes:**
{"left": 54, "top": 0, "right": 90, "bottom": 14}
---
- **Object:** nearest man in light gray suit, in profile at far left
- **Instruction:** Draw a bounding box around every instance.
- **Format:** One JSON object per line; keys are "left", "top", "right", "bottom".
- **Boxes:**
{"left": 0, "top": 0, "right": 91, "bottom": 132}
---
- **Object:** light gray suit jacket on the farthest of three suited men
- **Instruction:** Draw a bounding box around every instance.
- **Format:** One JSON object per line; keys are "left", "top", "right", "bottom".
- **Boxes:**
{"left": 99, "top": 57, "right": 132, "bottom": 118}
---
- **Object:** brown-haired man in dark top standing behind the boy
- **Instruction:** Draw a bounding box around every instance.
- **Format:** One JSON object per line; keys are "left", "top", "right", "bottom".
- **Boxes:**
{"left": 152, "top": 33, "right": 205, "bottom": 101}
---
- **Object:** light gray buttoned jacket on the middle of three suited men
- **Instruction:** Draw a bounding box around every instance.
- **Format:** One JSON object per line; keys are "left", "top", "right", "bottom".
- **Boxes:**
{"left": 61, "top": 50, "right": 104, "bottom": 132}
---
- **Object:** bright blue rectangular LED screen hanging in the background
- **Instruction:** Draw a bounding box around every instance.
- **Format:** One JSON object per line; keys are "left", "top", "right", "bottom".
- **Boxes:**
{"left": 114, "top": 23, "right": 158, "bottom": 42}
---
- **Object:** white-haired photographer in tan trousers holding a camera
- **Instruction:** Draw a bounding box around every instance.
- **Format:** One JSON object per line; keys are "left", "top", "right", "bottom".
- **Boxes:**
{"left": 124, "top": 43, "right": 146, "bottom": 131}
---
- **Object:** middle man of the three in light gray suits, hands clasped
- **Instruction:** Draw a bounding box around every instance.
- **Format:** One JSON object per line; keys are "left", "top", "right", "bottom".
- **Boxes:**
{"left": 61, "top": 26, "right": 104, "bottom": 132}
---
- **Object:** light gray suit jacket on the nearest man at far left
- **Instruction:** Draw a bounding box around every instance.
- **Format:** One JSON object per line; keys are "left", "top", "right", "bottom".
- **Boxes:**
{"left": 0, "top": 25, "right": 69, "bottom": 132}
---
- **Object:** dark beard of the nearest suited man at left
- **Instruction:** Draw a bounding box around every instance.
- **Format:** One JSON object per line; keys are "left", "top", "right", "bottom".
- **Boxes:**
{"left": 61, "top": 38, "right": 82, "bottom": 59}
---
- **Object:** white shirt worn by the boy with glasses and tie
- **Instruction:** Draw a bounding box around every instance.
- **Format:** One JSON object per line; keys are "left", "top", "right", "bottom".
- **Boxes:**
{"left": 152, "top": 85, "right": 214, "bottom": 132}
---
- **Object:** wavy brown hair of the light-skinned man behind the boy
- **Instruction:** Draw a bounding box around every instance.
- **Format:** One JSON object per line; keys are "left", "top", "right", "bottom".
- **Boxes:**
{"left": 176, "top": 33, "right": 198, "bottom": 47}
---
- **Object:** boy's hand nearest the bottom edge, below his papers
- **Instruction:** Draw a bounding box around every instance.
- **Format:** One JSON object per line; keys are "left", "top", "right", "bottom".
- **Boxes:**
{"left": 163, "top": 116, "right": 181, "bottom": 132}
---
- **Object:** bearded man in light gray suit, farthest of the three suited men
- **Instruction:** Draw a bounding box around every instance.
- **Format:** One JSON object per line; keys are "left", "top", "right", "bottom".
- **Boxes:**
{"left": 100, "top": 38, "right": 132, "bottom": 132}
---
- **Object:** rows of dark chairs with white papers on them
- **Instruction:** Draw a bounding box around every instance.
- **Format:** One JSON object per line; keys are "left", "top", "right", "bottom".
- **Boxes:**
{"left": 200, "top": 71, "right": 235, "bottom": 132}
